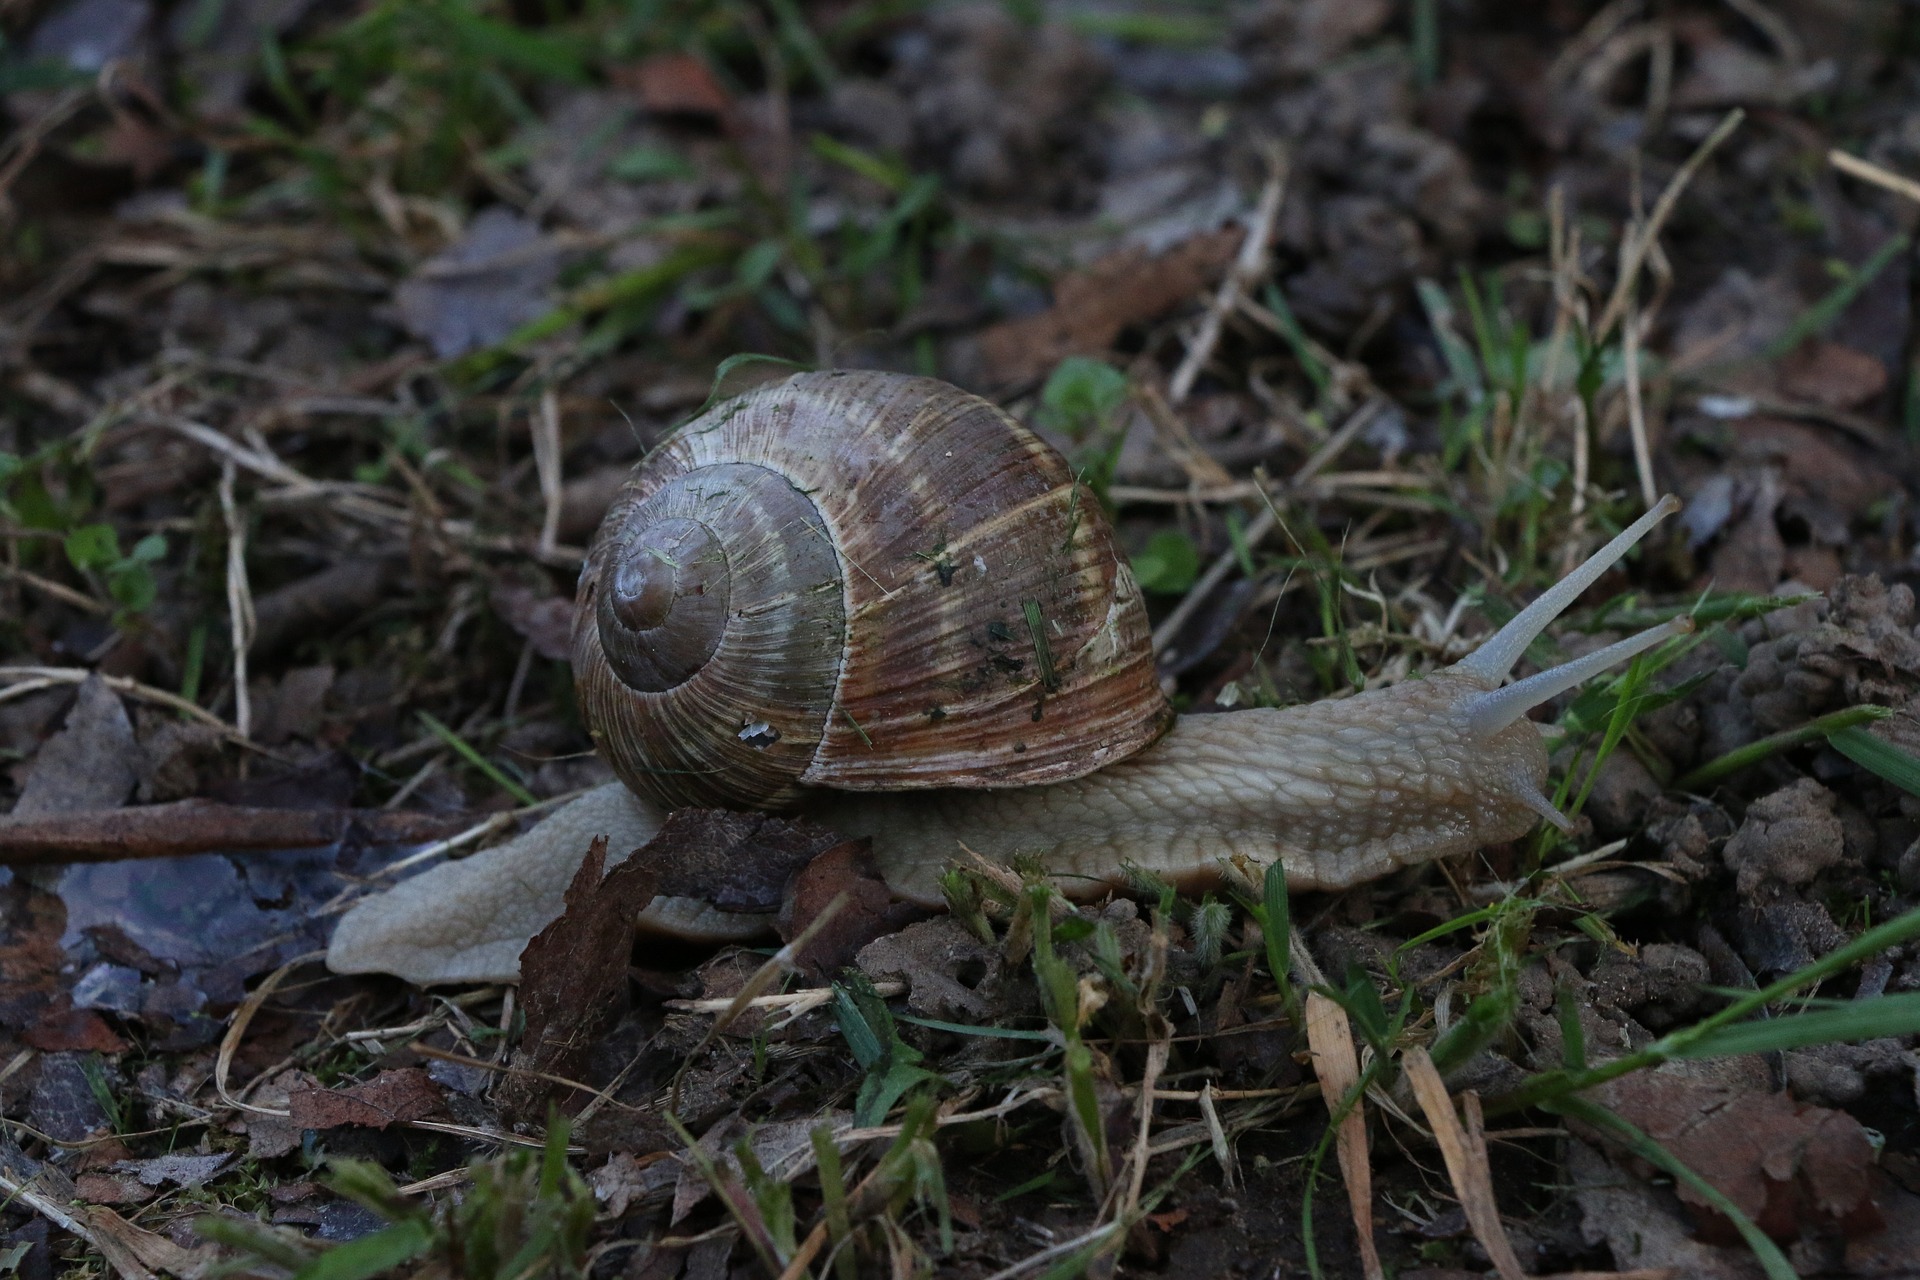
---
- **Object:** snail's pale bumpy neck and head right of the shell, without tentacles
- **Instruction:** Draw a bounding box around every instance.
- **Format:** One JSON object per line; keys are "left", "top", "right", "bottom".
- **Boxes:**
{"left": 808, "top": 670, "right": 1548, "bottom": 906}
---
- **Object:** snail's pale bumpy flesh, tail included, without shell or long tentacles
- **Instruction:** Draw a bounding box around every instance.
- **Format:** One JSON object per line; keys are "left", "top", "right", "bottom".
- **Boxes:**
{"left": 326, "top": 668, "right": 1551, "bottom": 984}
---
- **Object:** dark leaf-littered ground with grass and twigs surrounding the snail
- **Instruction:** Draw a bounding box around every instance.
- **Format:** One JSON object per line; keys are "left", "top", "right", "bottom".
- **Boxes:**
{"left": 0, "top": 0, "right": 1920, "bottom": 1276}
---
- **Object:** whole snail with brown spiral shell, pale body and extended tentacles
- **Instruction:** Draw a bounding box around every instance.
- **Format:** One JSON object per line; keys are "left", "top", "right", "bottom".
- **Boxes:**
{"left": 328, "top": 372, "right": 1692, "bottom": 983}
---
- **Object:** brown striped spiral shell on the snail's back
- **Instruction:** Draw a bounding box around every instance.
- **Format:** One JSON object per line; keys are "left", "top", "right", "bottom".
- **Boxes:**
{"left": 574, "top": 372, "right": 1173, "bottom": 806}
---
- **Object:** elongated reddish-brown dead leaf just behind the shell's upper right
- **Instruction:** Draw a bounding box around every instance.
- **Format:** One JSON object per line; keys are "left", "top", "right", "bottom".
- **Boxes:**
{"left": 979, "top": 226, "right": 1244, "bottom": 386}
